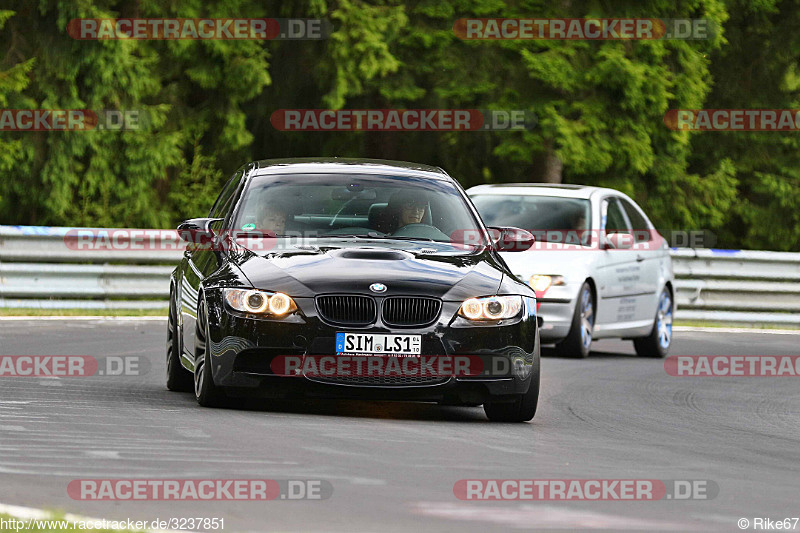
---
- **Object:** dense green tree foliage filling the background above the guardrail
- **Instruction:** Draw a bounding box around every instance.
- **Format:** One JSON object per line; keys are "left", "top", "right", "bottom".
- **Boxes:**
{"left": 0, "top": 0, "right": 800, "bottom": 250}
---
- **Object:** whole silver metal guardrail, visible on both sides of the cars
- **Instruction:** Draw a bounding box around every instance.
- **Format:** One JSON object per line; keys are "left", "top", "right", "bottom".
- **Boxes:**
{"left": 0, "top": 226, "right": 800, "bottom": 326}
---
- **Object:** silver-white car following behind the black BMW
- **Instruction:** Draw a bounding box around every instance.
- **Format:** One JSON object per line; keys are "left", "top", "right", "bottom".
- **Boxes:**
{"left": 467, "top": 184, "right": 675, "bottom": 357}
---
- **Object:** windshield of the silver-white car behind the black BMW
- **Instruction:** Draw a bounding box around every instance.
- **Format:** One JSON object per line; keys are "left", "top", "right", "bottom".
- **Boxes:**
{"left": 472, "top": 194, "right": 592, "bottom": 246}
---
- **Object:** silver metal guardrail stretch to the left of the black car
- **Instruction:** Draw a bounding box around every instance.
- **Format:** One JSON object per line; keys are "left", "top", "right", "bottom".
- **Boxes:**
{"left": 0, "top": 226, "right": 183, "bottom": 309}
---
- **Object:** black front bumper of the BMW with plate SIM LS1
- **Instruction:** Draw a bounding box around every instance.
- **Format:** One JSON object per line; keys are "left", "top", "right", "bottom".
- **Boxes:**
{"left": 206, "top": 291, "right": 539, "bottom": 404}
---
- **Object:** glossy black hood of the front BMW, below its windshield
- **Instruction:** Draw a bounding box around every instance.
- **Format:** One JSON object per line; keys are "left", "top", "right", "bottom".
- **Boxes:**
{"left": 232, "top": 246, "right": 503, "bottom": 301}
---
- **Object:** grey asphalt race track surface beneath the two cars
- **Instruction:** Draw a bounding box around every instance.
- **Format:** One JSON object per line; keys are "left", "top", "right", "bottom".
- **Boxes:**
{"left": 0, "top": 319, "right": 800, "bottom": 533}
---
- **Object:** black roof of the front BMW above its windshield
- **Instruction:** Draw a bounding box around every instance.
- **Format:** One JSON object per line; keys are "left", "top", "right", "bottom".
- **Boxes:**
{"left": 253, "top": 157, "right": 453, "bottom": 181}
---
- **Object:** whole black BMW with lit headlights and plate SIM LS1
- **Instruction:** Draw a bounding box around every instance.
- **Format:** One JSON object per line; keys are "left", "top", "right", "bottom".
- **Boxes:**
{"left": 167, "top": 158, "right": 540, "bottom": 421}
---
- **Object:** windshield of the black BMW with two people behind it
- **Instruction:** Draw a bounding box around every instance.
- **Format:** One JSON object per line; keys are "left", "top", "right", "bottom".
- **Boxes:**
{"left": 228, "top": 173, "right": 483, "bottom": 245}
